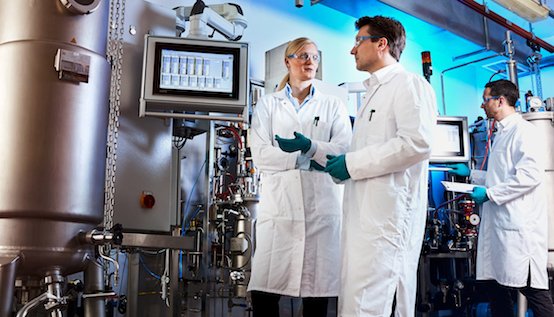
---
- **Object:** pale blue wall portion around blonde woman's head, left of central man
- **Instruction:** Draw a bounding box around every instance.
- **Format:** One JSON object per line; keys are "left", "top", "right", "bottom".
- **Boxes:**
{"left": 150, "top": 0, "right": 367, "bottom": 84}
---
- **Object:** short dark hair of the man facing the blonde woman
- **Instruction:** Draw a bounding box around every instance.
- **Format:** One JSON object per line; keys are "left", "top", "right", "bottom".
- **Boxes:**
{"left": 356, "top": 15, "right": 406, "bottom": 61}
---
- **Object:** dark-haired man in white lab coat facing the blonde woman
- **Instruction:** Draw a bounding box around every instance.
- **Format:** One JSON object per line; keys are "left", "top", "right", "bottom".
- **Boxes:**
{"left": 325, "top": 16, "right": 437, "bottom": 317}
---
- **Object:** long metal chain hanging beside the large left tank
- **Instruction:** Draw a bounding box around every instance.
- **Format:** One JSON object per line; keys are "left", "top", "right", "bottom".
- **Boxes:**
{"left": 104, "top": 0, "right": 125, "bottom": 230}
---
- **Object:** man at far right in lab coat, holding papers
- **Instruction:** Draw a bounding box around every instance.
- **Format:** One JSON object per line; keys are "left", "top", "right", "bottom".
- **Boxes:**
{"left": 450, "top": 80, "right": 554, "bottom": 317}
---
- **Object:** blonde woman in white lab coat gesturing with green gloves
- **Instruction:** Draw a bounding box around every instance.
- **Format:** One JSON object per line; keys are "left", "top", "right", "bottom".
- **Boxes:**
{"left": 248, "top": 38, "right": 352, "bottom": 317}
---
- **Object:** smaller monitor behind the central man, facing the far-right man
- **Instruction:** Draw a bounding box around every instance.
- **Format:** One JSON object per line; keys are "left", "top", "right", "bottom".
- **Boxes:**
{"left": 429, "top": 116, "right": 470, "bottom": 163}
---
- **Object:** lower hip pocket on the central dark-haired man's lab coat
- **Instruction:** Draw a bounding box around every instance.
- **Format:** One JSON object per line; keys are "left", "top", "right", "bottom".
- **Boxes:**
{"left": 360, "top": 181, "right": 407, "bottom": 236}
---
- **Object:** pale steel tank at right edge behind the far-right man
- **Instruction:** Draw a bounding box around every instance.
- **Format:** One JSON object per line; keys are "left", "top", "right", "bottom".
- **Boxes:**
{"left": 523, "top": 111, "right": 554, "bottom": 271}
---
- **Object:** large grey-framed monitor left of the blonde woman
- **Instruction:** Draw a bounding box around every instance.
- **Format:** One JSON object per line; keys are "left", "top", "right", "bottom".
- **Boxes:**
{"left": 141, "top": 36, "right": 249, "bottom": 113}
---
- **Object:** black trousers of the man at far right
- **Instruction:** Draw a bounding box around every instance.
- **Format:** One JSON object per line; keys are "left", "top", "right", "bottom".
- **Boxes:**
{"left": 485, "top": 281, "right": 554, "bottom": 317}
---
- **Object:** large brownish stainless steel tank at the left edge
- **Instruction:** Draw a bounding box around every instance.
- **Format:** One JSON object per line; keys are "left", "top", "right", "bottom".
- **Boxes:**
{"left": 0, "top": 0, "right": 111, "bottom": 317}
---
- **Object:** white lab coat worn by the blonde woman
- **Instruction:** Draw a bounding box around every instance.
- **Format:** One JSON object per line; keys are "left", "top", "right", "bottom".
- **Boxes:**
{"left": 248, "top": 89, "right": 352, "bottom": 297}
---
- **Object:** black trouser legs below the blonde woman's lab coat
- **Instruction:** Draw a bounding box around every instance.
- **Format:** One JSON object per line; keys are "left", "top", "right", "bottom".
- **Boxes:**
{"left": 252, "top": 291, "right": 329, "bottom": 317}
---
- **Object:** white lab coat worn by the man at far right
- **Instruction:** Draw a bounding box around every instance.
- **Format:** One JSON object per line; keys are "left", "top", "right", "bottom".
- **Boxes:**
{"left": 471, "top": 113, "right": 548, "bottom": 289}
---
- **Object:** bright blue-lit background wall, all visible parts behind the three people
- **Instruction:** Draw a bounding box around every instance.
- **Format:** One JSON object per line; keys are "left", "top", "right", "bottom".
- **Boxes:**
{"left": 148, "top": 0, "right": 554, "bottom": 122}
